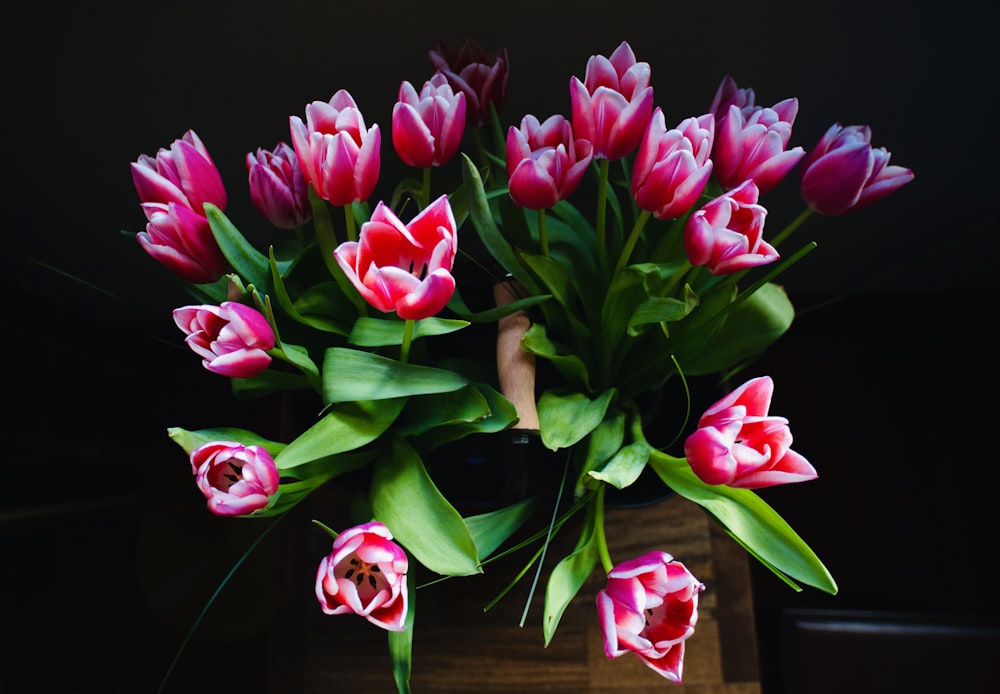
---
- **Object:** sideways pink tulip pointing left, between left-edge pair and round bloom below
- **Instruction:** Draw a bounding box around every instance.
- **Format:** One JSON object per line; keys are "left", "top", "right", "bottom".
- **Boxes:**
{"left": 173, "top": 301, "right": 274, "bottom": 378}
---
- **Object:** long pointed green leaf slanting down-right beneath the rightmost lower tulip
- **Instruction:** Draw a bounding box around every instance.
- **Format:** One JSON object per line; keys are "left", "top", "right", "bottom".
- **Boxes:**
{"left": 649, "top": 450, "right": 837, "bottom": 595}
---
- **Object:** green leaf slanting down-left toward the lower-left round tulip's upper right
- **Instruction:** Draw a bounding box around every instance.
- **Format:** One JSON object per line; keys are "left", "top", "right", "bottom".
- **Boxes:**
{"left": 274, "top": 398, "right": 405, "bottom": 470}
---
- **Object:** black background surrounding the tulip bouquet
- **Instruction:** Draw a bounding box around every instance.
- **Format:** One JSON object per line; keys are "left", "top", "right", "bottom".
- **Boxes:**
{"left": 0, "top": 0, "right": 1000, "bottom": 694}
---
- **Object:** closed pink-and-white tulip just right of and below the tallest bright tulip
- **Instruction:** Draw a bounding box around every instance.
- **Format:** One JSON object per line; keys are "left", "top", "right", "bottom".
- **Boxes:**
{"left": 632, "top": 107, "right": 715, "bottom": 219}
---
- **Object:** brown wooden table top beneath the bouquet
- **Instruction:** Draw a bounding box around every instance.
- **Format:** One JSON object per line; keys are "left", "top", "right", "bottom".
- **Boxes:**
{"left": 296, "top": 497, "right": 760, "bottom": 694}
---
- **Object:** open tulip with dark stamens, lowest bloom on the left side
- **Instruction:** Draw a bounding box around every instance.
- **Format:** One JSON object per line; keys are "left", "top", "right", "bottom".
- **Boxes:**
{"left": 316, "top": 521, "right": 409, "bottom": 631}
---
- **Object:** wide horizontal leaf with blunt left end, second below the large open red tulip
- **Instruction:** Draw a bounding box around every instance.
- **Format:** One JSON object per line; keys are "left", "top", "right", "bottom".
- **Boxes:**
{"left": 323, "top": 347, "right": 468, "bottom": 402}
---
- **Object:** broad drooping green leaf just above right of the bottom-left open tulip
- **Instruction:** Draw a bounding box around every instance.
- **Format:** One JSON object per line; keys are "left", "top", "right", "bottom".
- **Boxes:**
{"left": 371, "top": 439, "right": 482, "bottom": 576}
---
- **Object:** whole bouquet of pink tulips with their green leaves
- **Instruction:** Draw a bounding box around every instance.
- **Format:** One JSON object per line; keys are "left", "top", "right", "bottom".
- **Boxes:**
{"left": 132, "top": 42, "right": 913, "bottom": 692}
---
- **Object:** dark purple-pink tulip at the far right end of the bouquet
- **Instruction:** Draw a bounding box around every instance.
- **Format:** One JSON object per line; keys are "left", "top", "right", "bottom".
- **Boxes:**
{"left": 802, "top": 123, "right": 913, "bottom": 215}
